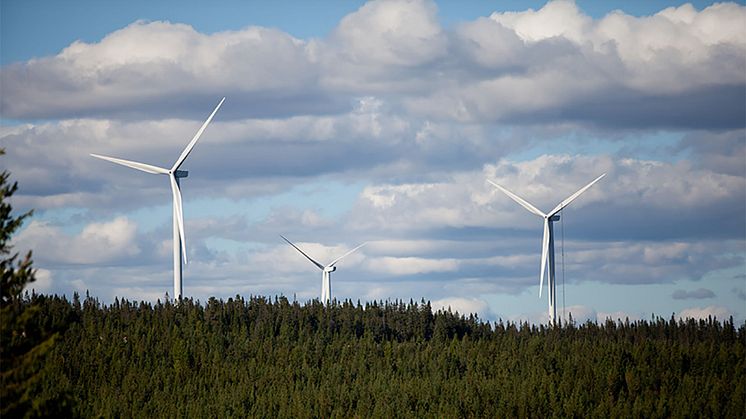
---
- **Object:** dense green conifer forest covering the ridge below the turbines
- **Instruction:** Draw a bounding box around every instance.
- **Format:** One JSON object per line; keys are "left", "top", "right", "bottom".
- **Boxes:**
{"left": 4, "top": 295, "right": 746, "bottom": 417}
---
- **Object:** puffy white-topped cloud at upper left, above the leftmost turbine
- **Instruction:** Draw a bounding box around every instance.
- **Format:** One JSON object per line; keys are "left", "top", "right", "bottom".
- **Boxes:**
{"left": 0, "top": 21, "right": 324, "bottom": 118}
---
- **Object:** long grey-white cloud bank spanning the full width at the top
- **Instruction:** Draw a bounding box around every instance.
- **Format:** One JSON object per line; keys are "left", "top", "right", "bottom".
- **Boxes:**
{"left": 0, "top": 0, "right": 746, "bottom": 127}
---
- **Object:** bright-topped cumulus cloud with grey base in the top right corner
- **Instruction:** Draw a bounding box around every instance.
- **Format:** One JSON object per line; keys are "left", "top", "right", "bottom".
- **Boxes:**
{"left": 430, "top": 1, "right": 746, "bottom": 127}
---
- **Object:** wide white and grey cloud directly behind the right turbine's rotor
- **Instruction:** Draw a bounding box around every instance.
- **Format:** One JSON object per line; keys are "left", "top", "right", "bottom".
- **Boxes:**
{"left": 346, "top": 155, "right": 746, "bottom": 241}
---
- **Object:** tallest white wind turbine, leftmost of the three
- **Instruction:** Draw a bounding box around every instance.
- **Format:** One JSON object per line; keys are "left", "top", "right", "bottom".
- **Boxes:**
{"left": 91, "top": 98, "right": 225, "bottom": 301}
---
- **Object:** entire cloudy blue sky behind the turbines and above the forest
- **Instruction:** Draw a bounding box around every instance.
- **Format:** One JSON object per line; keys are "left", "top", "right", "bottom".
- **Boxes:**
{"left": 0, "top": 0, "right": 746, "bottom": 321}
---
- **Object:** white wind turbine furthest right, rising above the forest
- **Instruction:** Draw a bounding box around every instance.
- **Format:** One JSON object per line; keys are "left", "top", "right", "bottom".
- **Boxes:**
{"left": 487, "top": 173, "right": 606, "bottom": 324}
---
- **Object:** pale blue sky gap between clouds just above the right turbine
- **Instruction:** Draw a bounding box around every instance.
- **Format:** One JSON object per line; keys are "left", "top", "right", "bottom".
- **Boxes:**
{"left": 507, "top": 131, "right": 690, "bottom": 163}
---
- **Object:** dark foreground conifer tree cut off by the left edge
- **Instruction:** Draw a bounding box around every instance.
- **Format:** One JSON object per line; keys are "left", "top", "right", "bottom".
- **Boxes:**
{"left": 0, "top": 149, "right": 71, "bottom": 418}
